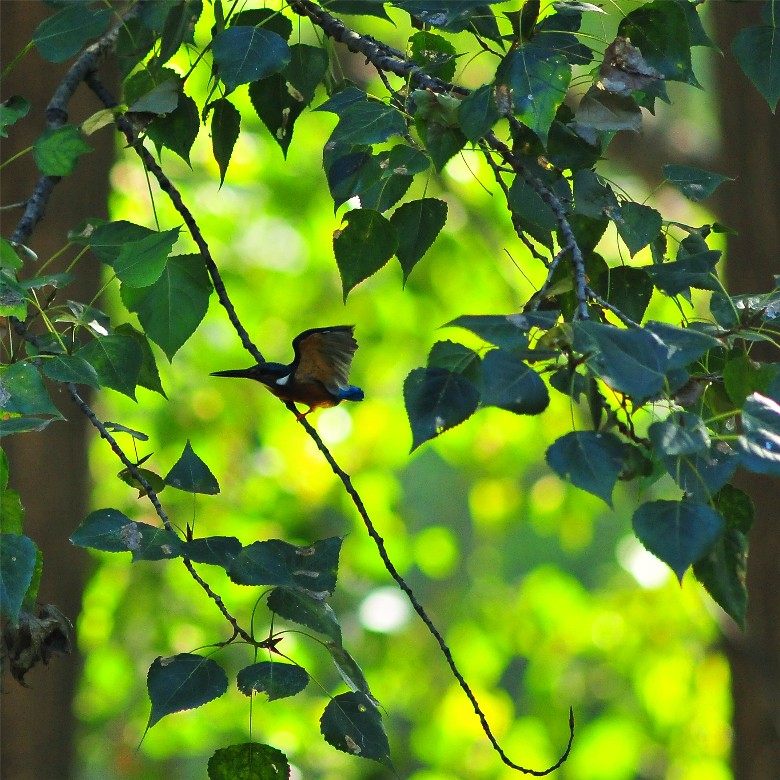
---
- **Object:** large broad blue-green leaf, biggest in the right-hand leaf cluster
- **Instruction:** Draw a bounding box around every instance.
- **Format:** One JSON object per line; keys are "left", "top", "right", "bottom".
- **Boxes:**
{"left": 574, "top": 321, "right": 668, "bottom": 403}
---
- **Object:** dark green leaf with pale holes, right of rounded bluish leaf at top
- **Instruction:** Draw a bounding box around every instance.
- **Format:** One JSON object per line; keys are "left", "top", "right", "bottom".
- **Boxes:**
{"left": 249, "top": 43, "right": 328, "bottom": 157}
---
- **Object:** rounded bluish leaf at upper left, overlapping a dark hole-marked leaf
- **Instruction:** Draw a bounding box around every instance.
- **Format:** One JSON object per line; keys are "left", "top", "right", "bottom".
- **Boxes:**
{"left": 213, "top": 26, "right": 290, "bottom": 90}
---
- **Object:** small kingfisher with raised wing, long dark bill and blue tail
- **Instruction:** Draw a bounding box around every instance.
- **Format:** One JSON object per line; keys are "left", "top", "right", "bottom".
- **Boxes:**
{"left": 211, "top": 325, "right": 364, "bottom": 420}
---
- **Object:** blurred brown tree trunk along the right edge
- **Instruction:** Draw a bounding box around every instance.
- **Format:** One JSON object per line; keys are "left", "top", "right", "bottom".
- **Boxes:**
{"left": 712, "top": 3, "right": 780, "bottom": 780}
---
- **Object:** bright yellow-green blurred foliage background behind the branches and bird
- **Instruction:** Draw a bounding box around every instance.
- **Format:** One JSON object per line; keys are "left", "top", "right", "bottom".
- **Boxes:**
{"left": 70, "top": 7, "right": 730, "bottom": 780}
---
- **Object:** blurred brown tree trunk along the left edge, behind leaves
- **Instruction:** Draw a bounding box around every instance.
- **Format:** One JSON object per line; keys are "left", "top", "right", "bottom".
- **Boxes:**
{"left": 0, "top": 2, "right": 114, "bottom": 780}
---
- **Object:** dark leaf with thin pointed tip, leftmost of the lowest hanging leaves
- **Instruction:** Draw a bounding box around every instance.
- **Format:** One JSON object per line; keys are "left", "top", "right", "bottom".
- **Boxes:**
{"left": 146, "top": 653, "right": 228, "bottom": 729}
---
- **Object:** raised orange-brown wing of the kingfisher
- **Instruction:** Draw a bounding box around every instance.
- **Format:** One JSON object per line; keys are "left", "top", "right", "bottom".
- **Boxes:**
{"left": 292, "top": 325, "right": 357, "bottom": 395}
